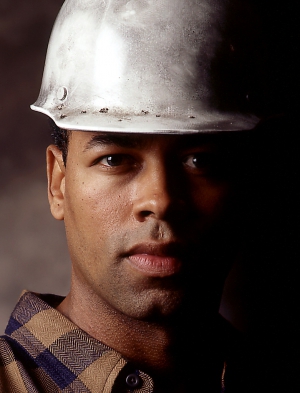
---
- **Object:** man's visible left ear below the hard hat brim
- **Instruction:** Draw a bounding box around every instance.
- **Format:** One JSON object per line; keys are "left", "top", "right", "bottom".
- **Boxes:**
{"left": 46, "top": 145, "right": 66, "bottom": 220}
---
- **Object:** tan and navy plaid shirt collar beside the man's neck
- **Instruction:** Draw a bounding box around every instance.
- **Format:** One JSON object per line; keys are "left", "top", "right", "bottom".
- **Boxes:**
{"left": 5, "top": 291, "right": 153, "bottom": 393}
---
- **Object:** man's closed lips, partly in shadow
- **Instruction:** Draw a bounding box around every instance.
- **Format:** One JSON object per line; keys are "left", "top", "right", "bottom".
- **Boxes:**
{"left": 127, "top": 244, "right": 182, "bottom": 277}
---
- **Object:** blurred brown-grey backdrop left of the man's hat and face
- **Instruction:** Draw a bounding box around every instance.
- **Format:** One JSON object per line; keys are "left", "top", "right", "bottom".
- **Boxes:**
{"left": 0, "top": 0, "right": 69, "bottom": 334}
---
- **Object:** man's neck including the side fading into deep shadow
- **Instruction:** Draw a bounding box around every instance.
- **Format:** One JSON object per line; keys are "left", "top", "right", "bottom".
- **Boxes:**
{"left": 57, "top": 274, "right": 224, "bottom": 382}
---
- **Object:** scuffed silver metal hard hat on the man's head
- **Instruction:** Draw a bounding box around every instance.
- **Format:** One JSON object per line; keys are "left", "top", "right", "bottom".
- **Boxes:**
{"left": 31, "top": 0, "right": 259, "bottom": 134}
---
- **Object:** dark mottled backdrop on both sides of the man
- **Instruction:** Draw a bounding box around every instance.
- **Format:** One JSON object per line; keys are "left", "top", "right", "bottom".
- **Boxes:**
{"left": 0, "top": 0, "right": 299, "bottom": 386}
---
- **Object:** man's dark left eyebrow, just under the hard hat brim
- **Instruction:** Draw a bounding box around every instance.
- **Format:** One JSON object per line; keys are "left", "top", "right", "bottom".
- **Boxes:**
{"left": 84, "top": 133, "right": 149, "bottom": 151}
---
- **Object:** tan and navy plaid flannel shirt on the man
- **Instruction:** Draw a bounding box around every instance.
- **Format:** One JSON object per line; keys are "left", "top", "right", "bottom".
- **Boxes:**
{"left": 0, "top": 292, "right": 229, "bottom": 393}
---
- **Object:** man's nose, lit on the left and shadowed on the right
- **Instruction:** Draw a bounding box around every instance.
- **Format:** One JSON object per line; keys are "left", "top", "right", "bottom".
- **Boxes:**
{"left": 133, "top": 162, "right": 185, "bottom": 222}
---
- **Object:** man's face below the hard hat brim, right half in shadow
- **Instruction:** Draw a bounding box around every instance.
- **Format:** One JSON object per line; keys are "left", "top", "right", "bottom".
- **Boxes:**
{"left": 48, "top": 131, "right": 240, "bottom": 320}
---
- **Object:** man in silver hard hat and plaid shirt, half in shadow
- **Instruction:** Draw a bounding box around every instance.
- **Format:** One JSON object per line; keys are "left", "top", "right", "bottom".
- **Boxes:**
{"left": 0, "top": 0, "right": 274, "bottom": 393}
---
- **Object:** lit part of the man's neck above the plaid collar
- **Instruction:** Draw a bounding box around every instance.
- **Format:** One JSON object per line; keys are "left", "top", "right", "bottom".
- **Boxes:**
{"left": 57, "top": 290, "right": 182, "bottom": 372}
